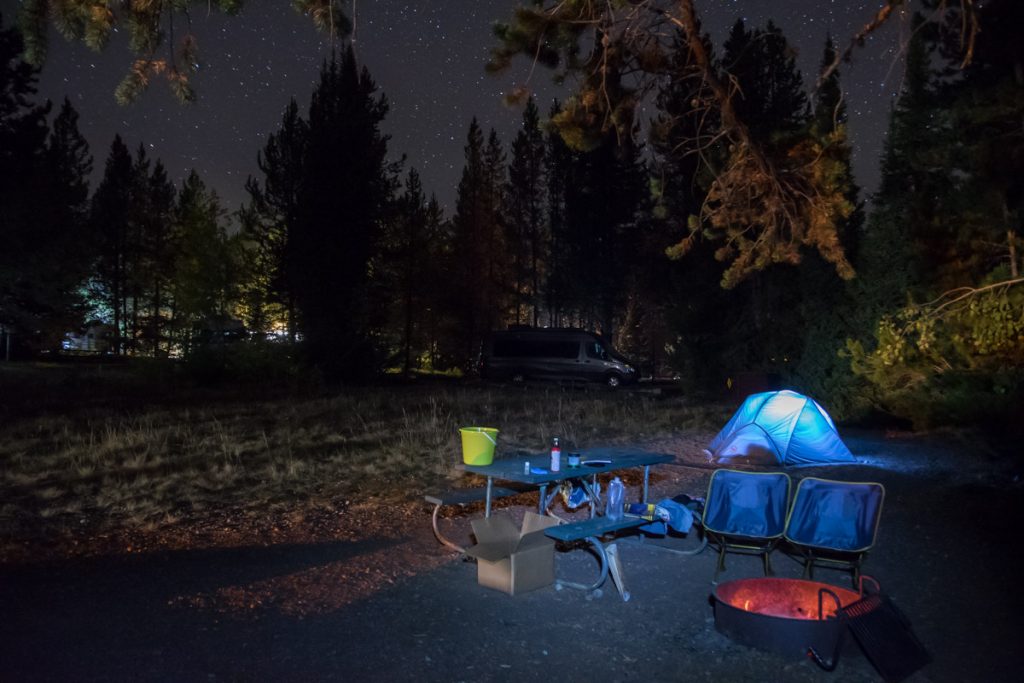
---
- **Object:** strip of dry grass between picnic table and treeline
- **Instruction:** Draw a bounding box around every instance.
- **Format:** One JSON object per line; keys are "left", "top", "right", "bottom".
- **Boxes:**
{"left": 0, "top": 362, "right": 721, "bottom": 539}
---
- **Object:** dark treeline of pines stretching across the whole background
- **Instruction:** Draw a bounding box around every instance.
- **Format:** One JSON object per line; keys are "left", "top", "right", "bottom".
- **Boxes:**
{"left": 0, "top": 0, "right": 1024, "bottom": 432}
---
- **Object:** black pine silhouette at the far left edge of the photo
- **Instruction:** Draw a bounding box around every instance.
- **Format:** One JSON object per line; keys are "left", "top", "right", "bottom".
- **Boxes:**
{"left": 0, "top": 16, "right": 89, "bottom": 354}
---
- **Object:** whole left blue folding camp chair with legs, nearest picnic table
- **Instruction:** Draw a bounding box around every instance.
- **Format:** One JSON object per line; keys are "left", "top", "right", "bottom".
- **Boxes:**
{"left": 702, "top": 469, "right": 790, "bottom": 582}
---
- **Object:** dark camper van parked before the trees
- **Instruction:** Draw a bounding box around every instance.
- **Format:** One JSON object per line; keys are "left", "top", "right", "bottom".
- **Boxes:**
{"left": 480, "top": 328, "right": 637, "bottom": 387}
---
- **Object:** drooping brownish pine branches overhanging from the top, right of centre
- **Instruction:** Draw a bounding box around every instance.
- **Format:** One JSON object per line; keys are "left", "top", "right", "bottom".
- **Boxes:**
{"left": 489, "top": 0, "right": 976, "bottom": 287}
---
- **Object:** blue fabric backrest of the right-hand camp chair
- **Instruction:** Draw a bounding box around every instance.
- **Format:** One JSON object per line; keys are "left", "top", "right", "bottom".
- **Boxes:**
{"left": 785, "top": 477, "right": 886, "bottom": 553}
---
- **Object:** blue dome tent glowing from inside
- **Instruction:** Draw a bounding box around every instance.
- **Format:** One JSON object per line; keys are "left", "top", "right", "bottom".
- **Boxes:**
{"left": 708, "top": 390, "right": 854, "bottom": 465}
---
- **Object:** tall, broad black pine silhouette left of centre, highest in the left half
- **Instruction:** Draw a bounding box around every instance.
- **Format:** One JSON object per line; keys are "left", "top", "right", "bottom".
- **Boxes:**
{"left": 288, "top": 47, "right": 397, "bottom": 380}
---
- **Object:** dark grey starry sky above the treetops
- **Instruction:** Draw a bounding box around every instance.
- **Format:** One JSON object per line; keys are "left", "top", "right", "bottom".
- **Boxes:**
{"left": 6, "top": 0, "right": 902, "bottom": 214}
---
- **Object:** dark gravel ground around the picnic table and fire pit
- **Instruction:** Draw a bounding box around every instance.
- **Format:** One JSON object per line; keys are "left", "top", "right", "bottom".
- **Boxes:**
{"left": 0, "top": 432, "right": 1024, "bottom": 683}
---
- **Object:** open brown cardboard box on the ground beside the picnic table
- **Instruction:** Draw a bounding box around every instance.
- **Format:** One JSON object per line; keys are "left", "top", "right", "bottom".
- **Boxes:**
{"left": 466, "top": 512, "right": 558, "bottom": 595}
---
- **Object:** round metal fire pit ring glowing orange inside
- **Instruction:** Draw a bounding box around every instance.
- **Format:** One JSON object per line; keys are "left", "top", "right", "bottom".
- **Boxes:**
{"left": 714, "top": 577, "right": 862, "bottom": 658}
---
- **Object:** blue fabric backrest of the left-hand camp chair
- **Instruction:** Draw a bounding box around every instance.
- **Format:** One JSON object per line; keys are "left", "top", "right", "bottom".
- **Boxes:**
{"left": 703, "top": 469, "right": 790, "bottom": 539}
